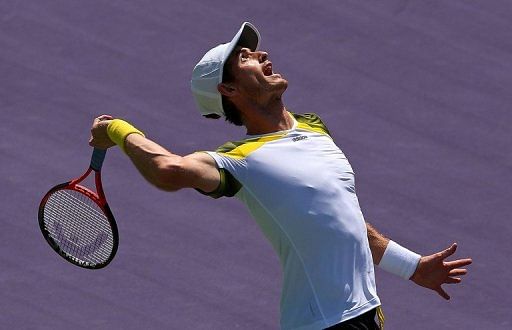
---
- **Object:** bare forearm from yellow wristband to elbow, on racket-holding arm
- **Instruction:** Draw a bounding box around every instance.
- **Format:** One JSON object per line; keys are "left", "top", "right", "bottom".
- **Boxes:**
{"left": 124, "top": 134, "right": 183, "bottom": 191}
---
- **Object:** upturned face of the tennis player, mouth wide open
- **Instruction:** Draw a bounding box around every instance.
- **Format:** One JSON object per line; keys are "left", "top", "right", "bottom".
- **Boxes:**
{"left": 226, "top": 48, "right": 288, "bottom": 104}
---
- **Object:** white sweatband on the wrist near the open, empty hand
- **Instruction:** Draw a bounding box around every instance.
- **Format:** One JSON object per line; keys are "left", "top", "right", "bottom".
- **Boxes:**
{"left": 379, "top": 241, "right": 421, "bottom": 280}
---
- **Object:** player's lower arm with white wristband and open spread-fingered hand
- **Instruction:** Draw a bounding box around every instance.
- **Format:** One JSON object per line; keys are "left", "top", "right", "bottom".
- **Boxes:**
{"left": 366, "top": 223, "right": 472, "bottom": 300}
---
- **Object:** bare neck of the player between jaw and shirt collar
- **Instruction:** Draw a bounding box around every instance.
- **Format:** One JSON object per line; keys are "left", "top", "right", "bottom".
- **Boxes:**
{"left": 243, "top": 99, "right": 293, "bottom": 135}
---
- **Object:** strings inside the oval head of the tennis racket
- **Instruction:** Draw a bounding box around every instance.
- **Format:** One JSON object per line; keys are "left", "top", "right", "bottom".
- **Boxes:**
{"left": 44, "top": 189, "right": 114, "bottom": 265}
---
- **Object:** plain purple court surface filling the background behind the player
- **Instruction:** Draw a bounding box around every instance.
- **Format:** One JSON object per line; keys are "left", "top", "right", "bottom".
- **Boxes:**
{"left": 0, "top": 0, "right": 512, "bottom": 329}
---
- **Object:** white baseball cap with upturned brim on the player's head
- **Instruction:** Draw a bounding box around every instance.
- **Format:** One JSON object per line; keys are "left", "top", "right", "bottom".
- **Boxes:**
{"left": 190, "top": 22, "right": 260, "bottom": 116}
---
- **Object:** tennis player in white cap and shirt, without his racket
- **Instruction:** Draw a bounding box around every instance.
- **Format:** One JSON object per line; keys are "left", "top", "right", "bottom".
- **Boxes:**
{"left": 90, "top": 22, "right": 471, "bottom": 329}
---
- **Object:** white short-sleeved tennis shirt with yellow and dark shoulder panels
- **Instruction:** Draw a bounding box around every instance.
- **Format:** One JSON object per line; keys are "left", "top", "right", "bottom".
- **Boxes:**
{"left": 200, "top": 114, "right": 380, "bottom": 329}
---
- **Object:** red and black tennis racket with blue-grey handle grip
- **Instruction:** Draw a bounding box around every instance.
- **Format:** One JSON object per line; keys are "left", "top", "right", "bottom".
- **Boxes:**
{"left": 39, "top": 149, "right": 119, "bottom": 269}
